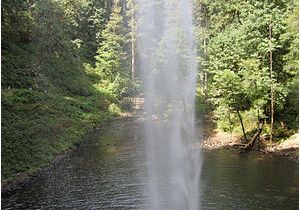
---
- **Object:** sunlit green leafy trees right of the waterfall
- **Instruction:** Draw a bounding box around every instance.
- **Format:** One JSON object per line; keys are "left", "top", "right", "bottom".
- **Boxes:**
{"left": 194, "top": 0, "right": 299, "bottom": 141}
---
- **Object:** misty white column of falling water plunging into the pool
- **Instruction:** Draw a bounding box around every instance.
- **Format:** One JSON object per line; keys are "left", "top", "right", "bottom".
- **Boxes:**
{"left": 137, "top": 0, "right": 201, "bottom": 209}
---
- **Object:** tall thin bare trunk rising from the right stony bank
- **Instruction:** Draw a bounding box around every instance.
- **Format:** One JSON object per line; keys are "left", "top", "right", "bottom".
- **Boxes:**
{"left": 269, "top": 23, "right": 275, "bottom": 143}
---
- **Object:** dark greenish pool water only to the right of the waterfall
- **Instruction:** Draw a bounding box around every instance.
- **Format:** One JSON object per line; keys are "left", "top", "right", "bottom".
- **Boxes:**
{"left": 201, "top": 151, "right": 299, "bottom": 209}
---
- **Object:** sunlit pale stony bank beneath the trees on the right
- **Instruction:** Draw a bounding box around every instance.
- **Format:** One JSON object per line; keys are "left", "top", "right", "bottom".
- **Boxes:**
{"left": 201, "top": 119, "right": 300, "bottom": 162}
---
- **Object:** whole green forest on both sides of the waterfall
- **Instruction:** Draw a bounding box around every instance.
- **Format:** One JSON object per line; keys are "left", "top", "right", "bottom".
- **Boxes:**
{"left": 1, "top": 0, "right": 299, "bottom": 180}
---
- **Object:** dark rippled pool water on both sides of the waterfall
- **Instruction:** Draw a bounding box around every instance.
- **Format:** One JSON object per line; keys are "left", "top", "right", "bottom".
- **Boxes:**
{"left": 1, "top": 121, "right": 299, "bottom": 210}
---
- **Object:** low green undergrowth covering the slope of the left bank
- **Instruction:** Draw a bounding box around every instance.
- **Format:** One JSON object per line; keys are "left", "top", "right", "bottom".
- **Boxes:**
{"left": 1, "top": 89, "right": 115, "bottom": 180}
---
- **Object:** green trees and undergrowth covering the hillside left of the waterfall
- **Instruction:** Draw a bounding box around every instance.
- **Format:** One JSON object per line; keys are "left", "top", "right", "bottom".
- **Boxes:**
{"left": 1, "top": 0, "right": 135, "bottom": 179}
